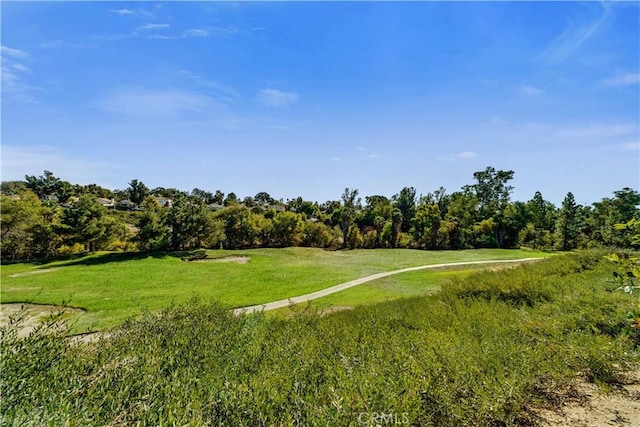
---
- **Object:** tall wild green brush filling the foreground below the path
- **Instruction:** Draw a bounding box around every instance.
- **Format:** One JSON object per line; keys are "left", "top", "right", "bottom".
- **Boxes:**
{"left": 0, "top": 252, "right": 640, "bottom": 426}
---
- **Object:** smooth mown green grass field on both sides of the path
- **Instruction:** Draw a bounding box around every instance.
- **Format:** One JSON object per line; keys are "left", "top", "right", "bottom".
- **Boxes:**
{"left": 0, "top": 248, "right": 548, "bottom": 332}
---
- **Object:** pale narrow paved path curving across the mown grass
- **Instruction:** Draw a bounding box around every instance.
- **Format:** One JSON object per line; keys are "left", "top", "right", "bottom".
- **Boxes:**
{"left": 233, "top": 258, "right": 540, "bottom": 314}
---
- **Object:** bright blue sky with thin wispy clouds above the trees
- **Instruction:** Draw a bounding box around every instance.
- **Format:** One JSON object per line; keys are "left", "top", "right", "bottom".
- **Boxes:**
{"left": 1, "top": 1, "right": 640, "bottom": 205}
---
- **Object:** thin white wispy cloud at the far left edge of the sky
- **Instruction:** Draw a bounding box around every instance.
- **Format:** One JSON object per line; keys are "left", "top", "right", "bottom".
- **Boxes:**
{"left": 0, "top": 46, "right": 42, "bottom": 104}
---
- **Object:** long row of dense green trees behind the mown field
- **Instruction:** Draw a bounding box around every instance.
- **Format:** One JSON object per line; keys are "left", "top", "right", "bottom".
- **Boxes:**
{"left": 0, "top": 167, "right": 640, "bottom": 260}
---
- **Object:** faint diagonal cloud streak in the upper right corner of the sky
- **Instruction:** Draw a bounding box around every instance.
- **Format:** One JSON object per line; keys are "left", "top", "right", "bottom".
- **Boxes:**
{"left": 540, "top": 2, "right": 611, "bottom": 61}
